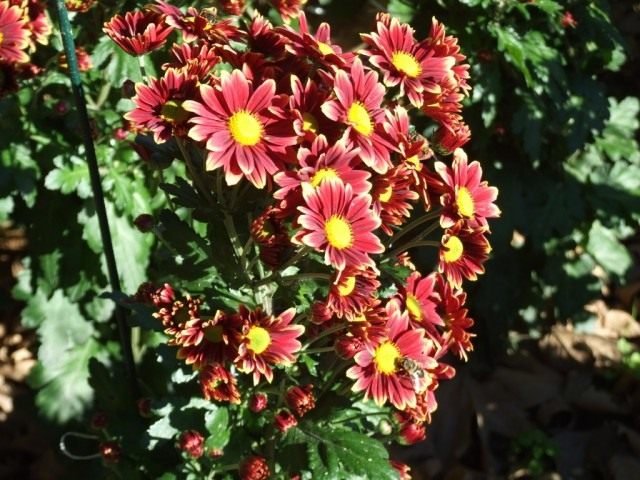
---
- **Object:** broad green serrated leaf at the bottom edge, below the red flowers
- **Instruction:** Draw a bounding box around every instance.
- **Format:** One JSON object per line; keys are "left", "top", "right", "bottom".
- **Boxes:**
{"left": 300, "top": 425, "right": 398, "bottom": 480}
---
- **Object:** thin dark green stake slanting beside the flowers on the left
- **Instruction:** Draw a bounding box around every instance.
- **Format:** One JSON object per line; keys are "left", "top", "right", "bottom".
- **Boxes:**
{"left": 56, "top": 0, "right": 140, "bottom": 400}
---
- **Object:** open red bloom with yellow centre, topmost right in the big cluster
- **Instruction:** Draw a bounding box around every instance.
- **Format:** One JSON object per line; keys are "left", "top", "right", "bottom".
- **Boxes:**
{"left": 361, "top": 13, "right": 456, "bottom": 108}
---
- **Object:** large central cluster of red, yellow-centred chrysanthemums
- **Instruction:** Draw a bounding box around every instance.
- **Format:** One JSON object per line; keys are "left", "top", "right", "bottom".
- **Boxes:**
{"left": 115, "top": 0, "right": 500, "bottom": 476}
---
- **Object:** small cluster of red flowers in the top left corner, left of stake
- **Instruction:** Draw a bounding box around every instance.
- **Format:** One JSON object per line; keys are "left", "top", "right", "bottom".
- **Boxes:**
{"left": 0, "top": 0, "right": 52, "bottom": 98}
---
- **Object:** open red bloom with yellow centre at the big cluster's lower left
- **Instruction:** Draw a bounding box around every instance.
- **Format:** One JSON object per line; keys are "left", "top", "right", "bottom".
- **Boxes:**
{"left": 234, "top": 306, "right": 304, "bottom": 385}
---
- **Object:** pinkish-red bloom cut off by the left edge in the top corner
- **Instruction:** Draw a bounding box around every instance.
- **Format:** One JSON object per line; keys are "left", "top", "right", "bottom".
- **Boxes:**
{"left": 0, "top": 2, "right": 31, "bottom": 63}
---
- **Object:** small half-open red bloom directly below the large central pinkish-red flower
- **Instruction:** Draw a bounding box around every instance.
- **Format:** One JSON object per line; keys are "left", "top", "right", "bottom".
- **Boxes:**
{"left": 326, "top": 267, "right": 380, "bottom": 318}
